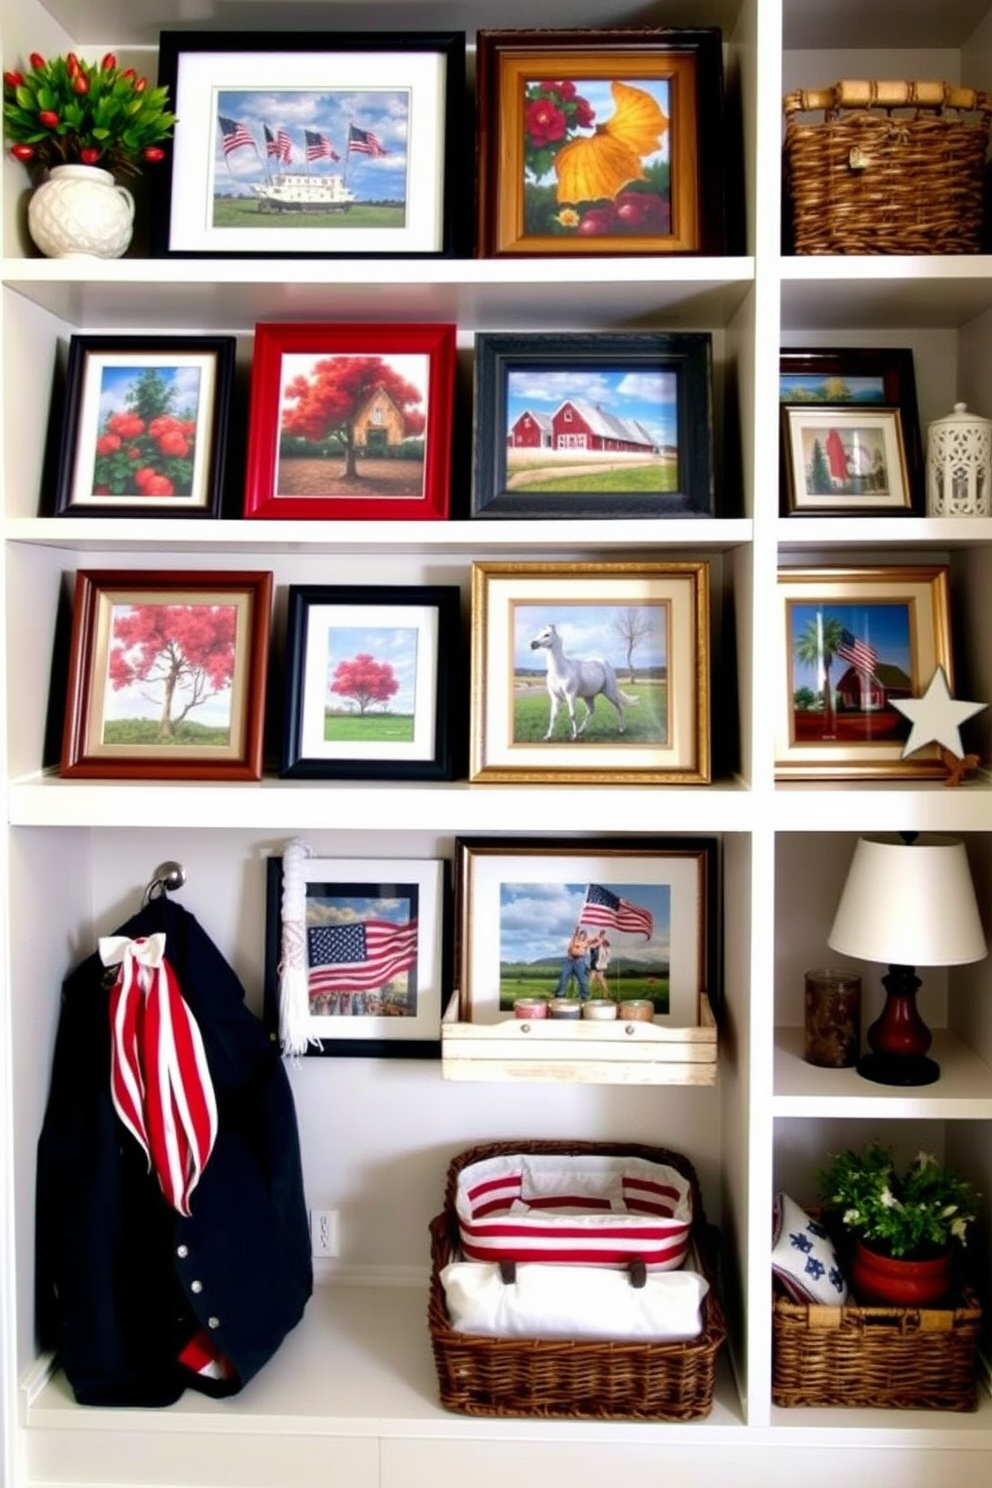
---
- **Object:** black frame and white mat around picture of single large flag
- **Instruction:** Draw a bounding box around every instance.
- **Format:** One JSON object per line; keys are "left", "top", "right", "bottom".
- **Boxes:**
{"left": 262, "top": 856, "right": 454, "bottom": 1059}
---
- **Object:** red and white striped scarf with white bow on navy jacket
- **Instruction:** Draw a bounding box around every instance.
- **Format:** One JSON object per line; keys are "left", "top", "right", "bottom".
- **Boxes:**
{"left": 100, "top": 931, "right": 217, "bottom": 1214}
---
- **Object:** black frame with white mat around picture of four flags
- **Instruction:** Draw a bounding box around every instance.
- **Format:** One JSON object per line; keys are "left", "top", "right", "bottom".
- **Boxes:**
{"left": 152, "top": 30, "right": 471, "bottom": 259}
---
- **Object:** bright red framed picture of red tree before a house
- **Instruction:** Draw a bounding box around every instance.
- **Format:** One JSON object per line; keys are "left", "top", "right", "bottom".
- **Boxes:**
{"left": 244, "top": 323, "right": 455, "bottom": 522}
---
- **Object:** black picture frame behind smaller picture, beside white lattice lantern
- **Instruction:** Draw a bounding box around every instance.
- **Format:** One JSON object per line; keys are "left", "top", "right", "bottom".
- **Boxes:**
{"left": 779, "top": 347, "right": 927, "bottom": 518}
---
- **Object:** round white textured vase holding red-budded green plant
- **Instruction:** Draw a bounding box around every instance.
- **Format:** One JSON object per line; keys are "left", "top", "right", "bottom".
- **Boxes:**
{"left": 28, "top": 165, "right": 134, "bottom": 259}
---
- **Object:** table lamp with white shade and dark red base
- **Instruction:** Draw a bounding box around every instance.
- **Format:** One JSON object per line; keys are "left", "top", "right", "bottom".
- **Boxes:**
{"left": 827, "top": 832, "right": 986, "bottom": 1085}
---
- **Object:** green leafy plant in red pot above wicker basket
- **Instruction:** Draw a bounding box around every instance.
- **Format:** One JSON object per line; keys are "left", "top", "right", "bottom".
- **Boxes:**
{"left": 819, "top": 1141, "right": 977, "bottom": 1306}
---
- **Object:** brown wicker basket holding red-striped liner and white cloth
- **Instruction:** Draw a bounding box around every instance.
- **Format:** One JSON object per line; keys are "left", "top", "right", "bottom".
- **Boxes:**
{"left": 427, "top": 1141, "right": 726, "bottom": 1421}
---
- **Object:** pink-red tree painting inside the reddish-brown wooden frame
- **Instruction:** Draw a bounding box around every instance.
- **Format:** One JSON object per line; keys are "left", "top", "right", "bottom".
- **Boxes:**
{"left": 104, "top": 604, "right": 238, "bottom": 745}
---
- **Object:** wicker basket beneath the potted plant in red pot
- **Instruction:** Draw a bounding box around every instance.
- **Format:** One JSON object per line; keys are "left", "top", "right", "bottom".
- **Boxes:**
{"left": 772, "top": 1287, "right": 982, "bottom": 1411}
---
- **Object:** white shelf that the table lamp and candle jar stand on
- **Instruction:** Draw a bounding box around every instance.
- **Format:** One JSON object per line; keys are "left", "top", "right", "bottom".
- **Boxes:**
{"left": 772, "top": 1027, "right": 992, "bottom": 1120}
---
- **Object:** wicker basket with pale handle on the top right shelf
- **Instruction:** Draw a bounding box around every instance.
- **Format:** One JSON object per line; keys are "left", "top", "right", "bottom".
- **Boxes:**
{"left": 784, "top": 82, "right": 992, "bottom": 253}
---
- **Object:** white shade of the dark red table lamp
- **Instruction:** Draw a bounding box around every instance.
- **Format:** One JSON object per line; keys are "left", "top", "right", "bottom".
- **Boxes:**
{"left": 827, "top": 835, "right": 986, "bottom": 966}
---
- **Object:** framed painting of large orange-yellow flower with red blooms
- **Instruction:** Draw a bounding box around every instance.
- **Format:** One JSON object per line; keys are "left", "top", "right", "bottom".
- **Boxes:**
{"left": 476, "top": 27, "right": 726, "bottom": 257}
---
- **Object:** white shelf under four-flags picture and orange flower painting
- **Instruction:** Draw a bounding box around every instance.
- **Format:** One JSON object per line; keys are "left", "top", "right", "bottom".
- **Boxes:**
{"left": 0, "top": 257, "right": 754, "bottom": 335}
